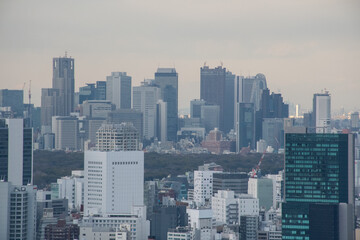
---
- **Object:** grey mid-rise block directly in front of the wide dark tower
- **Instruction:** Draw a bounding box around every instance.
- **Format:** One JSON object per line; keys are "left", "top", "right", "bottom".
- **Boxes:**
{"left": 201, "top": 105, "right": 220, "bottom": 132}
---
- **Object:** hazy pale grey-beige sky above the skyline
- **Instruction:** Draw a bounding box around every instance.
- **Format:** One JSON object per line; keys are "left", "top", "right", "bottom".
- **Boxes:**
{"left": 0, "top": 0, "right": 360, "bottom": 110}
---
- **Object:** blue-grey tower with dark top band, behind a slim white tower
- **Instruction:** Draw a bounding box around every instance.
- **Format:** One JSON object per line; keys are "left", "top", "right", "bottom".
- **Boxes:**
{"left": 154, "top": 68, "right": 179, "bottom": 142}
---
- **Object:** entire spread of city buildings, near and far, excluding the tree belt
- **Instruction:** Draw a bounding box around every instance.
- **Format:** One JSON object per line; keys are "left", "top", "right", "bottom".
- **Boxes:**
{"left": 0, "top": 53, "right": 360, "bottom": 240}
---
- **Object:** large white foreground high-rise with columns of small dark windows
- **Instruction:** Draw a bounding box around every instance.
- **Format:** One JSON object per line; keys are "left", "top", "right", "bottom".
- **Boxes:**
{"left": 84, "top": 151, "right": 144, "bottom": 215}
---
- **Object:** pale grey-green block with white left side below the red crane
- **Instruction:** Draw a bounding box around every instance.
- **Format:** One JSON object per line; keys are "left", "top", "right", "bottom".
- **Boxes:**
{"left": 248, "top": 178, "right": 276, "bottom": 210}
